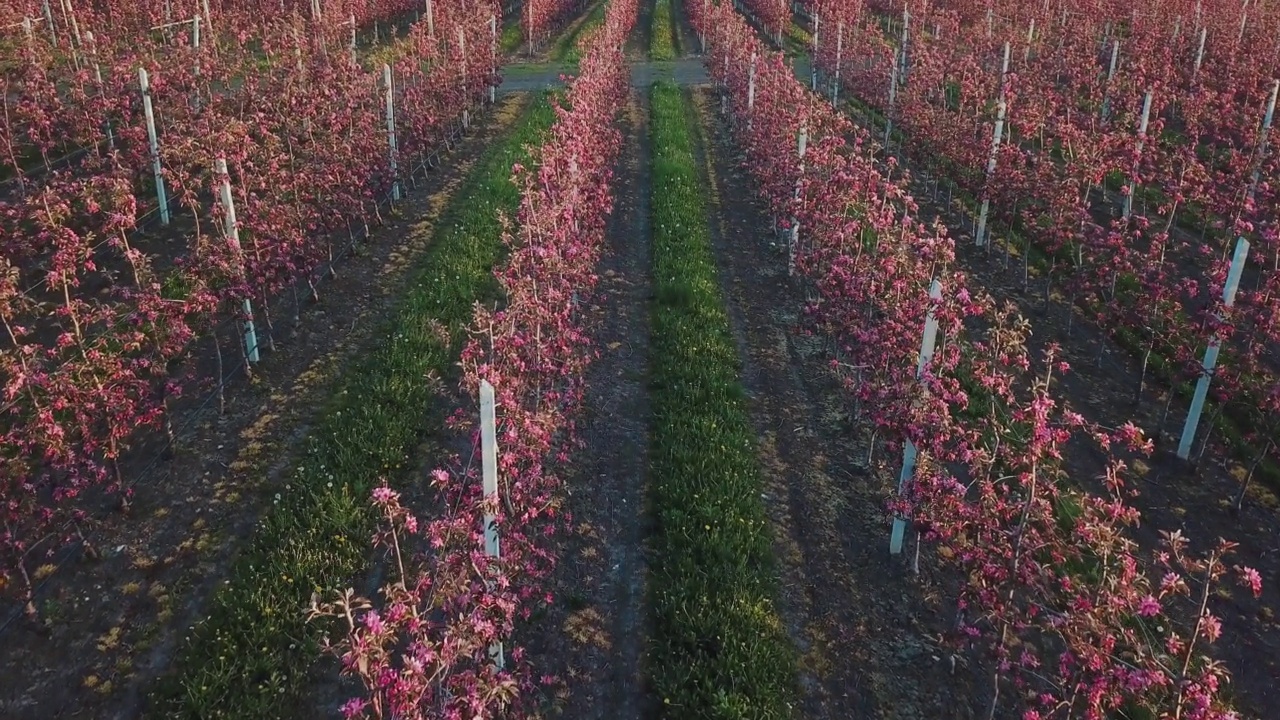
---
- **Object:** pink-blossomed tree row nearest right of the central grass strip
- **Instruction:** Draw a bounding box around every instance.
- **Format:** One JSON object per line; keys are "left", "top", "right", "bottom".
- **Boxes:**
{"left": 691, "top": 4, "right": 1261, "bottom": 720}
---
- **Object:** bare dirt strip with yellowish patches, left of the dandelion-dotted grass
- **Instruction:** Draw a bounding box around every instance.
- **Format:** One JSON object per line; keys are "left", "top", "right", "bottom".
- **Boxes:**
{"left": 0, "top": 97, "right": 521, "bottom": 720}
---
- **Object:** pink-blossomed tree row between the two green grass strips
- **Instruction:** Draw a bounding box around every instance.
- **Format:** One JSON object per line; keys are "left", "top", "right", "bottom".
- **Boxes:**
{"left": 314, "top": 0, "right": 637, "bottom": 707}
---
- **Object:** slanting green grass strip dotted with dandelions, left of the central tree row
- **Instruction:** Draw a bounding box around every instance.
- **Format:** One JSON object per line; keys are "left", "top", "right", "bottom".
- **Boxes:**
{"left": 145, "top": 100, "right": 554, "bottom": 719}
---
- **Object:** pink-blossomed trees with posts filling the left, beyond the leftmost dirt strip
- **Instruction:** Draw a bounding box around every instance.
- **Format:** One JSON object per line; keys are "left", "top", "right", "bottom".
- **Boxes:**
{"left": 0, "top": 0, "right": 499, "bottom": 607}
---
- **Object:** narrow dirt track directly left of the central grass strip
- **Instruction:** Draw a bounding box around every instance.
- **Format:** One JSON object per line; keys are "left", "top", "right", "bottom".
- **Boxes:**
{"left": 526, "top": 95, "right": 652, "bottom": 720}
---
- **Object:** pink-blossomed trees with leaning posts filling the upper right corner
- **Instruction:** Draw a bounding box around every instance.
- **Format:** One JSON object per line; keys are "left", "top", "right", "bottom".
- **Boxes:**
{"left": 810, "top": 0, "right": 1280, "bottom": 481}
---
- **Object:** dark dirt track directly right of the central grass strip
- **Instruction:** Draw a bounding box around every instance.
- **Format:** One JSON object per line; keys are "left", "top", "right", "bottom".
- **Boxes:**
{"left": 695, "top": 91, "right": 970, "bottom": 720}
